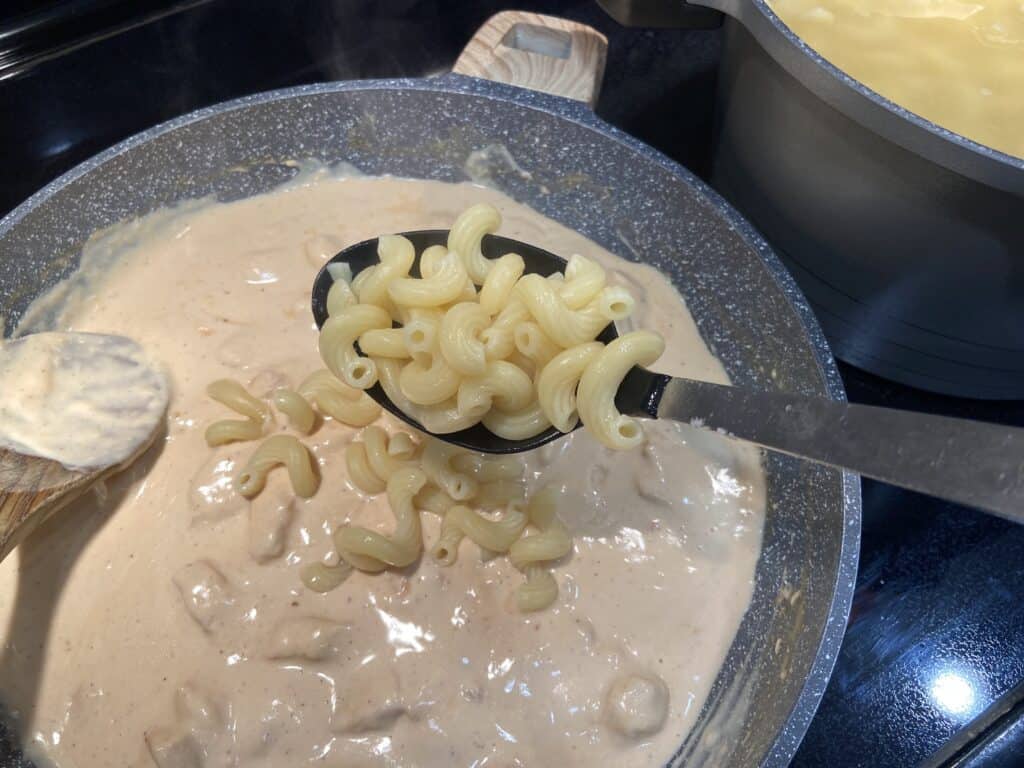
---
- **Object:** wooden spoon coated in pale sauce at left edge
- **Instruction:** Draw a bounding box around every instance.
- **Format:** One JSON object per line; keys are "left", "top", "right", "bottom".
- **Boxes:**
{"left": 0, "top": 333, "right": 168, "bottom": 560}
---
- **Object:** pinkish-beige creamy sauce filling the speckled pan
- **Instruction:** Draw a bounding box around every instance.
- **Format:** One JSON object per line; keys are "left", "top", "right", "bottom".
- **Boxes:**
{"left": 0, "top": 179, "right": 765, "bottom": 768}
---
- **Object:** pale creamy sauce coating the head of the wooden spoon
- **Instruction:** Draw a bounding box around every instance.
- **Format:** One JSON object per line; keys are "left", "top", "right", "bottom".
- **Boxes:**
{"left": 0, "top": 333, "right": 168, "bottom": 470}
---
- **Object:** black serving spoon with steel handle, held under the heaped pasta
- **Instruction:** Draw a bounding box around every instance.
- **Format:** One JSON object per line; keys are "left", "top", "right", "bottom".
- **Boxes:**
{"left": 312, "top": 230, "right": 1024, "bottom": 522}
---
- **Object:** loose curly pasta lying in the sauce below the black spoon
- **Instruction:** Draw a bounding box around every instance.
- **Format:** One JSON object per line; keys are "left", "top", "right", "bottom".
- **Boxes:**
{"left": 203, "top": 372, "right": 571, "bottom": 611}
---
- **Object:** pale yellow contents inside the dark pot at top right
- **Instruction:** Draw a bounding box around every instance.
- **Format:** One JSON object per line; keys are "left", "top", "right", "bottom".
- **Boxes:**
{"left": 768, "top": 0, "right": 1024, "bottom": 158}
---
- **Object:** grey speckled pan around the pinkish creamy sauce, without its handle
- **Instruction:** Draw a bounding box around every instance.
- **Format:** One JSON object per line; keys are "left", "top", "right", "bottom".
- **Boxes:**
{"left": 0, "top": 75, "right": 860, "bottom": 768}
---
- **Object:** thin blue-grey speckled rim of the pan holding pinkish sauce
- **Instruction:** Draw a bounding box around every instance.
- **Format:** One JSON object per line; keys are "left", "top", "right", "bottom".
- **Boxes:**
{"left": 0, "top": 74, "right": 861, "bottom": 768}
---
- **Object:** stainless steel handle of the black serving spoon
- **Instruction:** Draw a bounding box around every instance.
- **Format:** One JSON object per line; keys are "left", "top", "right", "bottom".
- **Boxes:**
{"left": 648, "top": 375, "right": 1024, "bottom": 522}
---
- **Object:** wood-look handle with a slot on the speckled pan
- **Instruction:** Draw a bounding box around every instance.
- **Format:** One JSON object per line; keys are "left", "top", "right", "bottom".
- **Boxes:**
{"left": 452, "top": 10, "right": 608, "bottom": 106}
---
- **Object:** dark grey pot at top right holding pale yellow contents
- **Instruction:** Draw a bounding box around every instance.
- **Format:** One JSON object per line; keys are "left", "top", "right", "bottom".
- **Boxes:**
{"left": 602, "top": 0, "right": 1024, "bottom": 398}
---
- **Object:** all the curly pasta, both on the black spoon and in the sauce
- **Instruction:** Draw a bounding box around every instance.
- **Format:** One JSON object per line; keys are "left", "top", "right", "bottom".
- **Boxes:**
{"left": 199, "top": 204, "right": 665, "bottom": 611}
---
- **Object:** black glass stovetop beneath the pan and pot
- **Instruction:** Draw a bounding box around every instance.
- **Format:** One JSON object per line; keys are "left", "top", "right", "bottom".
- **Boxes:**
{"left": 0, "top": 0, "right": 1024, "bottom": 768}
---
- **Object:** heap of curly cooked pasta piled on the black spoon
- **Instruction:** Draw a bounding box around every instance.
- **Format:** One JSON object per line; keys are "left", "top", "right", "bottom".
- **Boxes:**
{"left": 311, "top": 204, "right": 656, "bottom": 450}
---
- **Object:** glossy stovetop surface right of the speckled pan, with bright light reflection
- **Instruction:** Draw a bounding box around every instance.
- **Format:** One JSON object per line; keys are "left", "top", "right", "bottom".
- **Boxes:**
{"left": 794, "top": 366, "right": 1024, "bottom": 768}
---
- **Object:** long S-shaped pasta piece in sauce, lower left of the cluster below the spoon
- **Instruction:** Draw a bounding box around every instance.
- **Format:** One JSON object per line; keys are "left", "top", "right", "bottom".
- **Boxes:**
{"left": 334, "top": 466, "right": 427, "bottom": 572}
